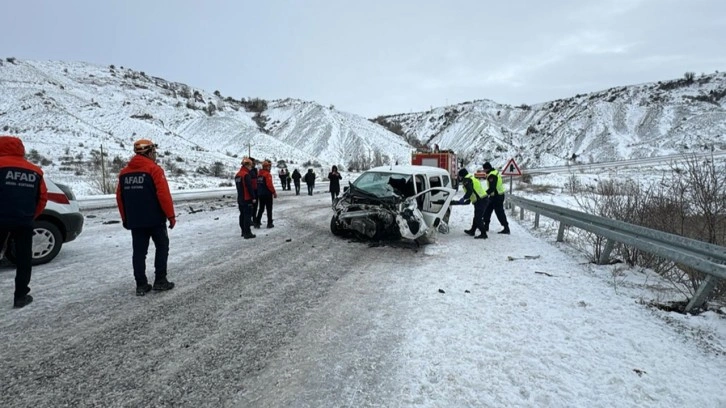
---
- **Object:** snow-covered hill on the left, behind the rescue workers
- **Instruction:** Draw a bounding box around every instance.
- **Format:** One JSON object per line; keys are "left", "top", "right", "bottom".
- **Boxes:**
{"left": 0, "top": 58, "right": 411, "bottom": 195}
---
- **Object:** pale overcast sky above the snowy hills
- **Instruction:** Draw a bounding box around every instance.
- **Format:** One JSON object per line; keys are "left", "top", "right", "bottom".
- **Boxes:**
{"left": 0, "top": 0, "right": 726, "bottom": 117}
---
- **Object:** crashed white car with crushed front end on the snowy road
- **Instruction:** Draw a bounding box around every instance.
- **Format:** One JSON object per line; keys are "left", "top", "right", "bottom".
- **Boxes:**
{"left": 330, "top": 166, "right": 456, "bottom": 243}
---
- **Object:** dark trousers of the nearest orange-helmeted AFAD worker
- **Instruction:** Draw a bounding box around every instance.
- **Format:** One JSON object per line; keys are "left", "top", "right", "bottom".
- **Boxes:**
{"left": 131, "top": 224, "right": 169, "bottom": 286}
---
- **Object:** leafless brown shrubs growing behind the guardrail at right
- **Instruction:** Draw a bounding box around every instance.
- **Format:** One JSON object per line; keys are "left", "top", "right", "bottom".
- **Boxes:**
{"left": 575, "top": 155, "right": 726, "bottom": 300}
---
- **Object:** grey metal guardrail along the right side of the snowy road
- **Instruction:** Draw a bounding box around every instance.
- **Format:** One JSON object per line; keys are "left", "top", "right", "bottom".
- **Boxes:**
{"left": 508, "top": 195, "right": 726, "bottom": 312}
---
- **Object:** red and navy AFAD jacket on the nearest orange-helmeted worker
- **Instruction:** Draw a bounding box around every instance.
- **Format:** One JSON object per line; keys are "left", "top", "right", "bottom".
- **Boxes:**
{"left": 116, "top": 154, "right": 174, "bottom": 229}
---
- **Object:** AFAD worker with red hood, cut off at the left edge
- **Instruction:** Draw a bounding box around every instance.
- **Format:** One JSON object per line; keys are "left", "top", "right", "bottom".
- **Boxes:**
{"left": 0, "top": 136, "right": 48, "bottom": 308}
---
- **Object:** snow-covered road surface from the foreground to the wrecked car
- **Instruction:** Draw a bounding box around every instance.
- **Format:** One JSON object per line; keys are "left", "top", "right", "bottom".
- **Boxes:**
{"left": 0, "top": 192, "right": 726, "bottom": 407}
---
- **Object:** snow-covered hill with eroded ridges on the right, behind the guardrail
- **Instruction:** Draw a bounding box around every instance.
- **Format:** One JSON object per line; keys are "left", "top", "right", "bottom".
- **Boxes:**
{"left": 383, "top": 73, "right": 726, "bottom": 167}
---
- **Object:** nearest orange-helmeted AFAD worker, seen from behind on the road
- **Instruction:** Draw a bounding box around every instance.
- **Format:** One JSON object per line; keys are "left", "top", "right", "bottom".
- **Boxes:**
{"left": 116, "top": 139, "right": 176, "bottom": 296}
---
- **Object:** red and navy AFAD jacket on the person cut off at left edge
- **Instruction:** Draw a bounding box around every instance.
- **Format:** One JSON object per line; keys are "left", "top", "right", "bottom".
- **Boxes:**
{"left": 0, "top": 136, "right": 48, "bottom": 227}
